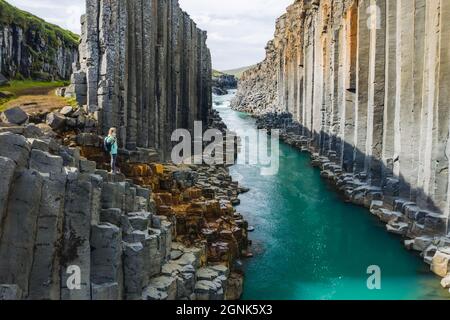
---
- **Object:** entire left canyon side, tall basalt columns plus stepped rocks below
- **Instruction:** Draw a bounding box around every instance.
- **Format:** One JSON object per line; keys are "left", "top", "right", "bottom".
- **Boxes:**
{"left": 0, "top": 0, "right": 249, "bottom": 300}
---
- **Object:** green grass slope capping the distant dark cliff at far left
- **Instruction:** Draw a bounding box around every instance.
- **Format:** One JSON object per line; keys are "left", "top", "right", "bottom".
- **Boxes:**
{"left": 0, "top": 0, "right": 79, "bottom": 46}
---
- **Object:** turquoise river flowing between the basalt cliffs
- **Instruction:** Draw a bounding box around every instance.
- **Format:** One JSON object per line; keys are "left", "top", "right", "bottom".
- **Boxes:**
{"left": 214, "top": 92, "right": 448, "bottom": 300}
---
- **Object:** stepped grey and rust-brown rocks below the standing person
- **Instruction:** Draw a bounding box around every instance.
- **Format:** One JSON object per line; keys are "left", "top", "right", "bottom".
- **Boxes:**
{"left": 0, "top": 100, "right": 248, "bottom": 300}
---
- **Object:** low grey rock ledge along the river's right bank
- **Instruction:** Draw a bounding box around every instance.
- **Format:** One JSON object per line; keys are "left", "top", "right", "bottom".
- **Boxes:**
{"left": 253, "top": 113, "right": 450, "bottom": 289}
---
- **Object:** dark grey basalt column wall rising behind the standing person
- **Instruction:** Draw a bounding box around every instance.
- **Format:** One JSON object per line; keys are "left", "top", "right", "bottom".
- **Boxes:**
{"left": 67, "top": 0, "right": 212, "bottom": 159}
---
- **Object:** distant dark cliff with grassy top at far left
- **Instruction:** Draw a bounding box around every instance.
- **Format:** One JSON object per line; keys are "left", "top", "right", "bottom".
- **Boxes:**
{"left": 0, "top": 0, "right": 78, "bottom": 80}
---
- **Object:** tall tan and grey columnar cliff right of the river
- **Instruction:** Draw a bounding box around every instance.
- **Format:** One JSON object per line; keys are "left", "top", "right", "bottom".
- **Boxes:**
{"left": 233, "top": 0, "right": 450, "bottom": 233}
